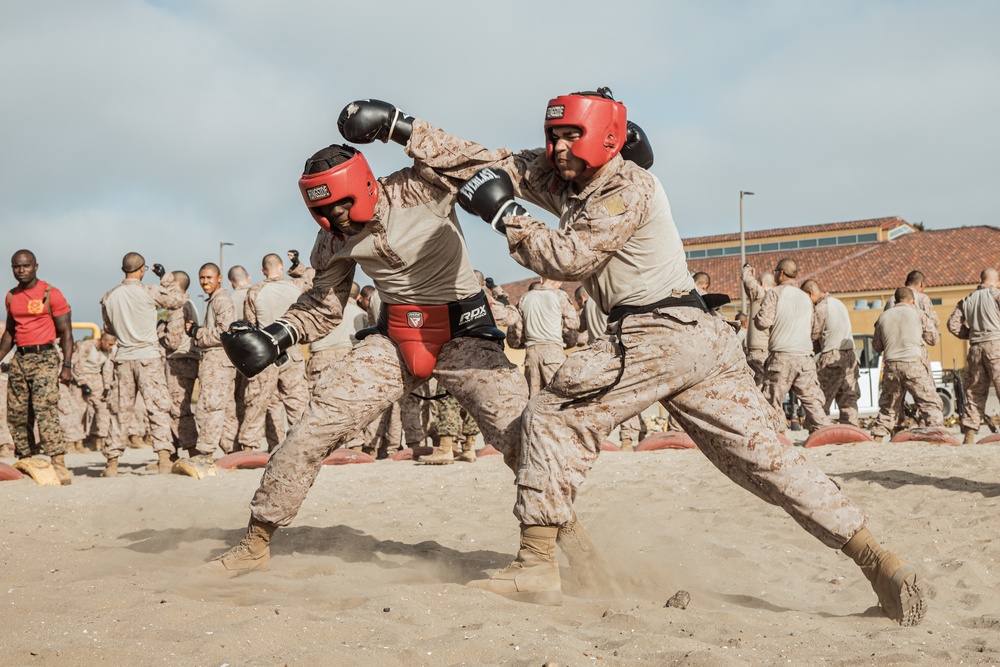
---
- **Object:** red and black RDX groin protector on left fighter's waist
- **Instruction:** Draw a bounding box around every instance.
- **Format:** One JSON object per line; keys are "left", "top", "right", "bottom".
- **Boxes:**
{"left": 356, "top": 292, "right": 505, "bottom": 380}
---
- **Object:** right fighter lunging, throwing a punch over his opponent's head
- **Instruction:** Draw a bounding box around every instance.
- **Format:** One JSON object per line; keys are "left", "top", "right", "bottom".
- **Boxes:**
{"left": 341, "top": 89, "right": 925, "bottom": 625}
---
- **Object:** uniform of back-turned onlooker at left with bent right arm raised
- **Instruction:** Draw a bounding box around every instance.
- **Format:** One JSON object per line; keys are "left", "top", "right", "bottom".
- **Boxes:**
{"left": 101, "top": 273, "right": 185, "bottom": 460}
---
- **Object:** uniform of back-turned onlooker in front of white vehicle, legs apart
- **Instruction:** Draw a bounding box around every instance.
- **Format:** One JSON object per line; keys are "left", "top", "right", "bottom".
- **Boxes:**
{"left": 872, "top": 303, "right": 944, "bottom": 437}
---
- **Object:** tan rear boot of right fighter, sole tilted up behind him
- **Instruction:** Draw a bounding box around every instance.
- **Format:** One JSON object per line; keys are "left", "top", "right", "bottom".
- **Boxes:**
{"left": 841, "top": 528, "right": 927, "bottom": 626}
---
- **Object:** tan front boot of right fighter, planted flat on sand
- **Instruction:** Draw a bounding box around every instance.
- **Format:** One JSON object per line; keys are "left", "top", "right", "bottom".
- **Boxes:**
{"left": 468, "top": 525, "right": 562, "bottom": 606}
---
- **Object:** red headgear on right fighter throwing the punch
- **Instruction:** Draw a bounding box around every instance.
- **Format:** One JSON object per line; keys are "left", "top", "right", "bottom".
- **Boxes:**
{"left": 545, "top": 88, "right": 627, "bottom": 169}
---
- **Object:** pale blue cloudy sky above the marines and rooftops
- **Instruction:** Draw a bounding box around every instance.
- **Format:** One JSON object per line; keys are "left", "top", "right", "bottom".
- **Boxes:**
{"left": 0, "top": 0, "right": 1000, "bottom": 328}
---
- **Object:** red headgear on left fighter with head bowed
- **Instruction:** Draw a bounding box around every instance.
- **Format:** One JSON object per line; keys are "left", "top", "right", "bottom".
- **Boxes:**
{"left": 299, "top": 146, "right": 378, "bottom": 230}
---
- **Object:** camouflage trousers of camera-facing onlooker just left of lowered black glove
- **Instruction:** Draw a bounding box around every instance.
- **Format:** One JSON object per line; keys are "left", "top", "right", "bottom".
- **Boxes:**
{"left": 195, "top": 347, "right": 237, "bottom": 456}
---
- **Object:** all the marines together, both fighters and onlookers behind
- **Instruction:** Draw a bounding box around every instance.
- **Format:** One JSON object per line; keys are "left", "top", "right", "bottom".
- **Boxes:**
{"left": 0, "top": 88, "right": 1000, "bottom": 625}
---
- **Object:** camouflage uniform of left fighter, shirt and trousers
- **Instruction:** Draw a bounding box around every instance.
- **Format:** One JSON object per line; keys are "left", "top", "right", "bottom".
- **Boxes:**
{"left": 250, "top": 141, "right": 528, "bottom": 526}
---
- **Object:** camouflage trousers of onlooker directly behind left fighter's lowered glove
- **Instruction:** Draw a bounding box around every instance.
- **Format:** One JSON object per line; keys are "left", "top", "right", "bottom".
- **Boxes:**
{"left": 236, "top": 350, "right": 309, "bottom": 451}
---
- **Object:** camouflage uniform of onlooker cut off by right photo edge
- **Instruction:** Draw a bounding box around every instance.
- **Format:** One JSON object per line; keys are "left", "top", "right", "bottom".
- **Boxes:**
{"left": 948, "top": 285, "right": 1000, "bottom": 431}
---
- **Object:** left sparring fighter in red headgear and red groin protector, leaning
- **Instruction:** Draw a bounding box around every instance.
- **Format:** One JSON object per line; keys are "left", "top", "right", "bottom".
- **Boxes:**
{"left": 205, "top": 133, "right": 591, "bottom": 576}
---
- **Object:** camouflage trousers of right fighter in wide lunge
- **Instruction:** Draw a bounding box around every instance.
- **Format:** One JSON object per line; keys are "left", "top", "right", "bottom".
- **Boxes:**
{"left": 514, "top": 308, "right": 866, "bottom": 549}
